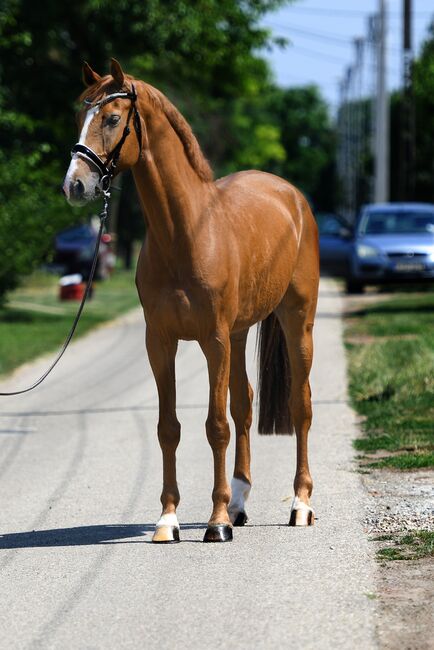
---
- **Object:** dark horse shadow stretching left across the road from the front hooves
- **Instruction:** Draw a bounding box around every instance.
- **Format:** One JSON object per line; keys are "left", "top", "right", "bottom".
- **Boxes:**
{"left": 0, "top": 523, "right": 206, "bottom": 551}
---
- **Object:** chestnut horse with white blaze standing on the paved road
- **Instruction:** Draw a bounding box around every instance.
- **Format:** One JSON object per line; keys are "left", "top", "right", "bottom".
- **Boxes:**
{"left": 63, "top": 59, "right": 319, "bottom": 543}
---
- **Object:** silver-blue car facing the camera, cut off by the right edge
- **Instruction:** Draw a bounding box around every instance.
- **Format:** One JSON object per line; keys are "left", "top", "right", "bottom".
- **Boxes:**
{"left": 347, "top": 203, "right": 434, "bottom": 293}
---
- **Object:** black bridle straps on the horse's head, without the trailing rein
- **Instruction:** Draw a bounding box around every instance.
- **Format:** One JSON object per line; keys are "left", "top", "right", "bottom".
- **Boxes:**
{"left": 71, "top": 84, "right": 142, "bottom": 192}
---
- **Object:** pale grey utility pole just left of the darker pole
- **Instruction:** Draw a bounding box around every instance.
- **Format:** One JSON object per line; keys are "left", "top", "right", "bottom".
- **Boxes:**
{"left": 374, "top": 0, "right": 389, "bottom": 203}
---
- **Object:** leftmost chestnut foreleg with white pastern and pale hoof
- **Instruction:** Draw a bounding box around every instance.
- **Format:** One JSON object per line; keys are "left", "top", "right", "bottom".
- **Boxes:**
{"left": 146, "top": 328, "right": 181, "bottom": 543}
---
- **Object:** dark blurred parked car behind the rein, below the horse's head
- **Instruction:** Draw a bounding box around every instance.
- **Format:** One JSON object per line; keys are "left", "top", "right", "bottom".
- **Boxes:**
{"left": 54, "top": 224, "right": 114, "bottom": 280}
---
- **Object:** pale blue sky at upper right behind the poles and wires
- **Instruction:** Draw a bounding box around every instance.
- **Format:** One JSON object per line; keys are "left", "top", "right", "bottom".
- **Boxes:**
{"left": 262, "top": 0, "right": 434, "bottom": 109}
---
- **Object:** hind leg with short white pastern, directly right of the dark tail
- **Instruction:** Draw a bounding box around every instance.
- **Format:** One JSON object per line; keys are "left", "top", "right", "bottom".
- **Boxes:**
{"left": 276, "top": 299, "right": 316, "bottom": 526}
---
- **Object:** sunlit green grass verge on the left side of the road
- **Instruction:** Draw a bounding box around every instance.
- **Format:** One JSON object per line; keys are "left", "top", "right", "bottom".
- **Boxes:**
{"left": 0, "top": 270, "right": 139, "bottom": 375}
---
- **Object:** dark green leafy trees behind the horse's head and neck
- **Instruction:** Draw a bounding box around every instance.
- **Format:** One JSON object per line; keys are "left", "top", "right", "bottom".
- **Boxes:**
{"left": 0, "top": 0, "right": 292, "bottom": 297}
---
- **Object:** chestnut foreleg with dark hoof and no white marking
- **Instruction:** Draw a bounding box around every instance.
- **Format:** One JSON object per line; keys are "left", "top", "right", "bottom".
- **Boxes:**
{"left": 201, "top": 331, "right": 232, "bottom": 542}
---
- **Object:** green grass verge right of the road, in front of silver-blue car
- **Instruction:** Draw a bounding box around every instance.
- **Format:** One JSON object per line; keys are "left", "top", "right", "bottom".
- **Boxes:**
{"left": 346, "top": 292, "right": 434, "bottom": 469}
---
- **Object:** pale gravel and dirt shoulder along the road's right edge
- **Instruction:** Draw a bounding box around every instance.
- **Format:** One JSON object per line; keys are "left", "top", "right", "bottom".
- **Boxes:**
{"left": 344, "top": 294, "right": 434, "bottom": 650}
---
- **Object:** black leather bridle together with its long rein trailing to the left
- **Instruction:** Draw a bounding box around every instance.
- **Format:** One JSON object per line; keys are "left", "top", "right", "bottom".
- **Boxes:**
{"left": 0, "top": 85, "right": 142, "bottom": 397}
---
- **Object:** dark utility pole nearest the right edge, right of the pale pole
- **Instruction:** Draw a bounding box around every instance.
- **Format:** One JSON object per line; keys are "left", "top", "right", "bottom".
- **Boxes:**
{"left": 399, "top": 0, "right": 415, "bottom": 201}
